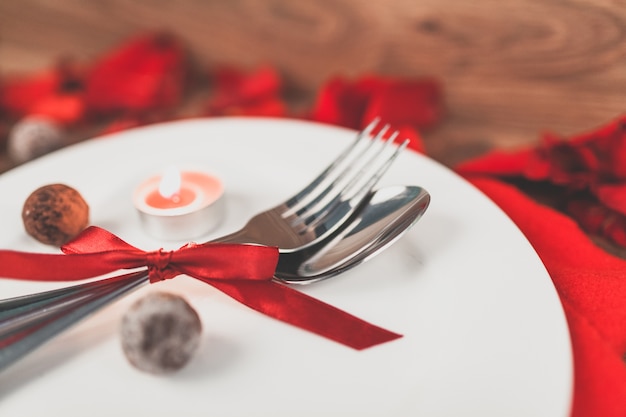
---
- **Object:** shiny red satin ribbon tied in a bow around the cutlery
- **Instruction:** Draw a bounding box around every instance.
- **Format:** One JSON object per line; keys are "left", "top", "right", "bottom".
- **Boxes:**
{"left": 0, "top": 226, "right": 402, "bottom": 350}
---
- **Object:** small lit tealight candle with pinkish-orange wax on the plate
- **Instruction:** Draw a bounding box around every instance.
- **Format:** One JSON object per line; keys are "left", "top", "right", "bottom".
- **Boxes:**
{"left": 133, "top": 164, "right": 224, "bottom": 240}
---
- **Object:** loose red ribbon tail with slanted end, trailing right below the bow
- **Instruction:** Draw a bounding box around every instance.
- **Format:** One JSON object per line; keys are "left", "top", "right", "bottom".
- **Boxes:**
{"left": 198, "top": 278, "right": 402, "bottom": 350}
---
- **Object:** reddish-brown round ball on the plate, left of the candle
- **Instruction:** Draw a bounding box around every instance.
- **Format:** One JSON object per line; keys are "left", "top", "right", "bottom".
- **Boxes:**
{"left": 22, "top": 184, "right": 89, "bottom": 246}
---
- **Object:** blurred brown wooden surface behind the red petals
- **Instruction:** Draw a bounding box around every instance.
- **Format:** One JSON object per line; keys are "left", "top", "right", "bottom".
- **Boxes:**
{"left": 0, "top": 0, "right": 626, "bottom": 164}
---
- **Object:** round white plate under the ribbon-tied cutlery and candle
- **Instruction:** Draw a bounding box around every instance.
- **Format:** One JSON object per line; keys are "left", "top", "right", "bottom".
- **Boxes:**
{"left": 0, "top": 118, "right": 572, "bottom": 417}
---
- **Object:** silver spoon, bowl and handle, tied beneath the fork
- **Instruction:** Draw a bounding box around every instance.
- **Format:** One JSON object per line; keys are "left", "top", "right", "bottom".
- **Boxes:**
{"left": 0, "top": 186, "right": 430, "bottom": 370}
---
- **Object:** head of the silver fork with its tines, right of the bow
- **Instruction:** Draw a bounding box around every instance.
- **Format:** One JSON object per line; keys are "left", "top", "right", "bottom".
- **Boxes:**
{"left": 214, "top": 119, "right": 409, "bottom": 253}
